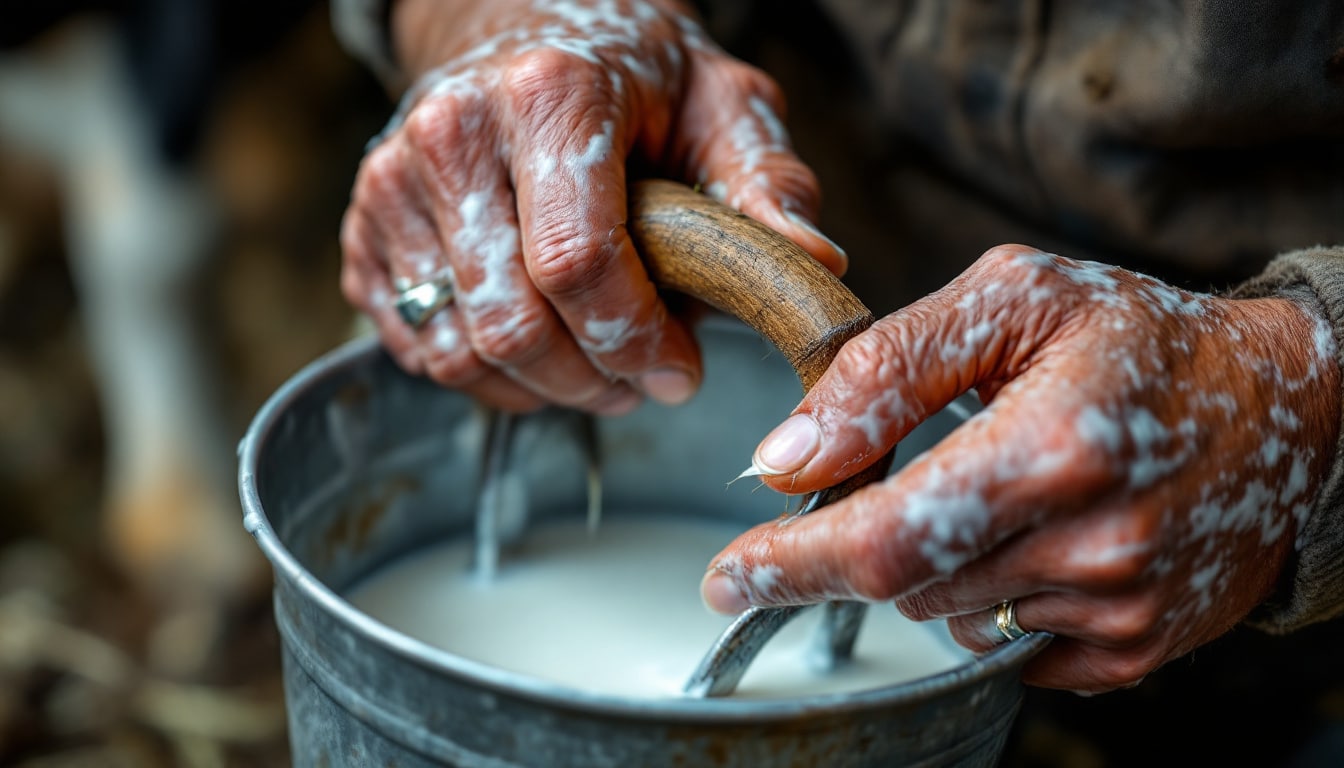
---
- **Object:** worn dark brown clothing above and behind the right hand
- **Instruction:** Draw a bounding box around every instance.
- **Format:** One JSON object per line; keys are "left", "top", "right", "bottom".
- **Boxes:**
{"left": 821, "top": 0, "right": 1344, "bottom": 273}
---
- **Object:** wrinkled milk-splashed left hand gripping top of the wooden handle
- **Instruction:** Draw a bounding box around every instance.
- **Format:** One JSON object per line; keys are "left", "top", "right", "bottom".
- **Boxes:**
{"left": 341, "top": 0, "right": 845, "bottom": 413}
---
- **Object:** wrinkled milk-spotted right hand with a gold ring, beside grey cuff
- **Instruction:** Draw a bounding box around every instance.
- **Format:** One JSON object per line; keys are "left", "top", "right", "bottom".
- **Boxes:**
{"left": 703, "top": 246, "right": 1340, "bottom": 693}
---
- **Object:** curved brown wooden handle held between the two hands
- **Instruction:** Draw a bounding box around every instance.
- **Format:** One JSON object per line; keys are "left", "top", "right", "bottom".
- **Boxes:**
{"left": 630, "top": 180, "right": 872, "bottom": 390}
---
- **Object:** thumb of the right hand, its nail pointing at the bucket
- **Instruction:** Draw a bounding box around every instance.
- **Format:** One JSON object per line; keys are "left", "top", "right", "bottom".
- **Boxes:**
{"left": 753, "top": 246, "right": 1068, "bottom": 492}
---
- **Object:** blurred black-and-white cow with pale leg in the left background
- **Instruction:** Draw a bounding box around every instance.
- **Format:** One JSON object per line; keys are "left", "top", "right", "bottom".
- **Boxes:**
{"left": 0, "top": 0, "right": 331, "bottom": 672}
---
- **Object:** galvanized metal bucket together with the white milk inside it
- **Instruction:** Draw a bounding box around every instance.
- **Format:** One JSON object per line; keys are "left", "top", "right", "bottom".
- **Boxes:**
{"left": 239, "top": 334, "right": 1050, "bottom": 768}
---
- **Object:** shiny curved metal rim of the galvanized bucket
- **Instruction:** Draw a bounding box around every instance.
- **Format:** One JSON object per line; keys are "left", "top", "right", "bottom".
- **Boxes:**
{"left": 238, "top": 329, "right": 1052, "bottom": 722}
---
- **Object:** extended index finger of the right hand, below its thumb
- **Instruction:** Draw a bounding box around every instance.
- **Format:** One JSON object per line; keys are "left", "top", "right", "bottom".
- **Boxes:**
{"left": 702, "top": 387, "right": 1117, "bottom": 613}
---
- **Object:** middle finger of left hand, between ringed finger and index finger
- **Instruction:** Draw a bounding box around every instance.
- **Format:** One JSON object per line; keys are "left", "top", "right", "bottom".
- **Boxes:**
{"left": 406, "top": 90, "right": 637, "bottom": 413}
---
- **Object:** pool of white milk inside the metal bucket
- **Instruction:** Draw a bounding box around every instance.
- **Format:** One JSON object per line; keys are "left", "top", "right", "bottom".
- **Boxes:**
{"left": 345, "top": 514, "right": 972, "bottom": 698}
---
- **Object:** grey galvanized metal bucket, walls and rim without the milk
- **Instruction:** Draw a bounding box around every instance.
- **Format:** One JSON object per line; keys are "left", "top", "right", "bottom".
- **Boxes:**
{"left": 239, "top": 317, "right": 1048, "bottom": 768}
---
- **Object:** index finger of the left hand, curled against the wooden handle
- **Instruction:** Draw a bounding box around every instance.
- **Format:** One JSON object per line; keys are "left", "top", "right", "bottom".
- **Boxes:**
{"left": 513, "top": 52, "right": 702, "bottom": 404}
